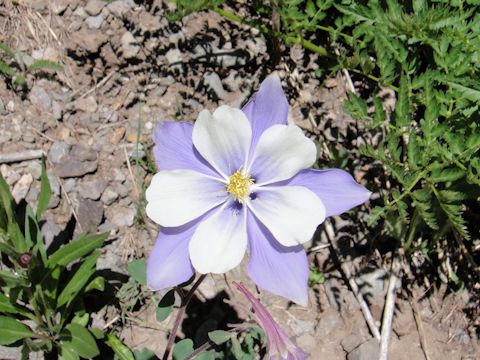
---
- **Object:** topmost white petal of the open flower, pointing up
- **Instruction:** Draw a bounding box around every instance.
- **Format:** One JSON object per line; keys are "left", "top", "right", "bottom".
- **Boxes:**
{"left": 192, "top": 105, "right": 252, "bottom": 179}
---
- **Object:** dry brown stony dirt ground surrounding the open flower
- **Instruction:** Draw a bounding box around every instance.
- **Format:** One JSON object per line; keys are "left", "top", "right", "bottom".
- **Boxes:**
{"left": 0, "top": 0, "right": 479, "bottom": 360}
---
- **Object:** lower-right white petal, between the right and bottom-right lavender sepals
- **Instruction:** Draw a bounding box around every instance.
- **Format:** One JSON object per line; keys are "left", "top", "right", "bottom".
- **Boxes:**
{"left": 248, "top": 186, "right": 325, "bottom": 246}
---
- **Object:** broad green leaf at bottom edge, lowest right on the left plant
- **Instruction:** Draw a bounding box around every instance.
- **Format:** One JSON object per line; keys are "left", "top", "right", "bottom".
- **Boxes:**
{"left": 60, "top": 324, "right": 100, "bottom": 359}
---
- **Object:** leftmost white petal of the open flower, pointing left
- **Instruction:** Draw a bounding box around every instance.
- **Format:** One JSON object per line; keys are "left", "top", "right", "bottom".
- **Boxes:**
{"left": 145, "top": 170, "right": 228, "bottom": 227}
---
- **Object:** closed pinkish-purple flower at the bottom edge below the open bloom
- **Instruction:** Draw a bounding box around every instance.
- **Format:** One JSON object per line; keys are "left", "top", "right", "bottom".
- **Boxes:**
{"left": 233, "top": 282, "right": 307, "bottom": 360}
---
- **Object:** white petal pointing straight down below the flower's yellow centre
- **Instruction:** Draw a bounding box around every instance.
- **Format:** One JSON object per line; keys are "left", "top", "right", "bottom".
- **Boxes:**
{"left": 188, "top": 205, "right": 247, "bottom": 274}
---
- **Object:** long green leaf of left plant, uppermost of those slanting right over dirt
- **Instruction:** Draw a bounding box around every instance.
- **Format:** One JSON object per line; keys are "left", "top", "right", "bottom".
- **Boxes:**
{"left": 47, "top": 233, "right": 108, "bottom": 269}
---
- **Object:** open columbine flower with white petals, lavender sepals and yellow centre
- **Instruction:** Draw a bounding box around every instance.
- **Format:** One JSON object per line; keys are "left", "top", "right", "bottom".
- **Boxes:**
{"left": 146, "top": 75, "right": 370, "bottom": 304}
